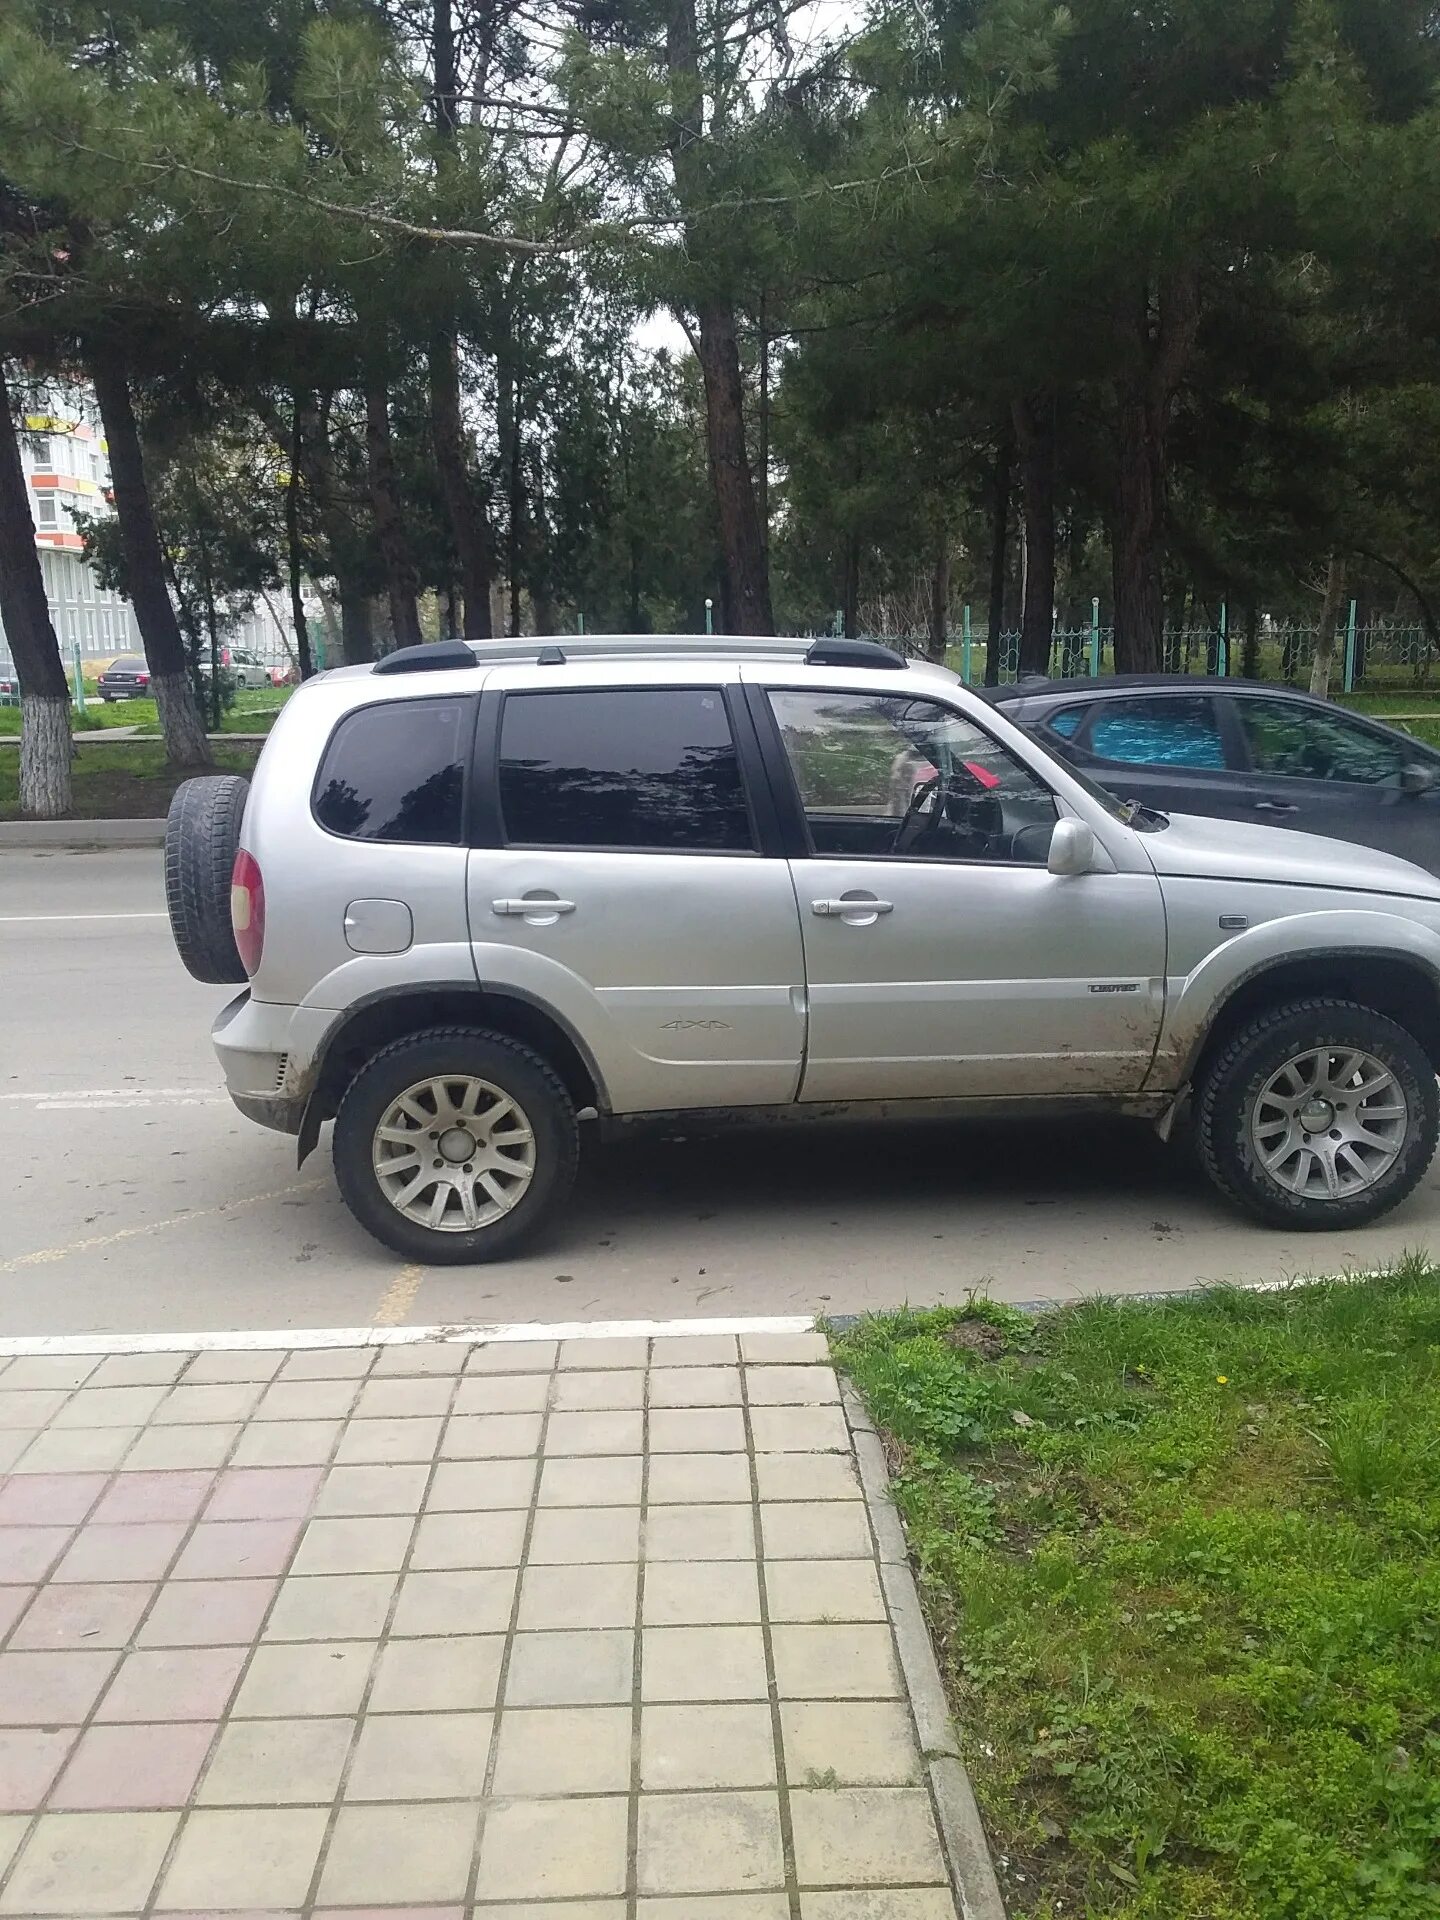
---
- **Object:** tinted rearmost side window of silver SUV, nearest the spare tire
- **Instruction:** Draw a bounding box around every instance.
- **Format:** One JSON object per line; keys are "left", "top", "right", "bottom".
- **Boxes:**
{"left": 315, "top": 701, "right": 474, "bottom": 847}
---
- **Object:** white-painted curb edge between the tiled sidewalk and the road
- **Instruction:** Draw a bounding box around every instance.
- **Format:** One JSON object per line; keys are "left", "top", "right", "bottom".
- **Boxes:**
{"left": 0, "top": 1313, "right": 814, "bottom": 1359}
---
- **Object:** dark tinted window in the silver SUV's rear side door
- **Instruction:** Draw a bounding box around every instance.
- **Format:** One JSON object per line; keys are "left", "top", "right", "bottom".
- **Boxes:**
{"left": 499, "top": 687, "right": 755, "bottom": 852}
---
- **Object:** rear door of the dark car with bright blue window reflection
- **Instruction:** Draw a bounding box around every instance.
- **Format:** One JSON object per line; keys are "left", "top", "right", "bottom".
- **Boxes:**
{"left": 1048, "top": 689, "right": 1233, "bottom": 814}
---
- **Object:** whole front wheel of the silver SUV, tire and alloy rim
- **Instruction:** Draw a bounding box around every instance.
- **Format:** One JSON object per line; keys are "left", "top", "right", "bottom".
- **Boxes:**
{"left": 1196, "top": 1000, "right": 1440, "bottom": 1233}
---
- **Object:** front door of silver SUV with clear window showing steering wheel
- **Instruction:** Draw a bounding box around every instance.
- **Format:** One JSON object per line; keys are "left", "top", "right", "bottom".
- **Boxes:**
{"left": 758, "top": 684, "right": 1165, "bottom": 1100}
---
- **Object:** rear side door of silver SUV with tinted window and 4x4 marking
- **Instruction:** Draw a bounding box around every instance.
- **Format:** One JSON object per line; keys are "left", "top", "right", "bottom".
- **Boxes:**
{"left": 467, "top": 668, "right": 804, "bottom": 1112}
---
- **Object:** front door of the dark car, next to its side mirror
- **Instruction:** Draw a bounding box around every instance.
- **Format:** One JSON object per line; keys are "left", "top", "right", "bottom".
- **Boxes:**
{"left": 1229, "top": 691, "right": 1440, "bottom": 870}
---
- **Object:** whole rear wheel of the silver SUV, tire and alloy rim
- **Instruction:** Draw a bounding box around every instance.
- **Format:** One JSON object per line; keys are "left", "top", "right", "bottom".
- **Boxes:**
{"left": 332, "top": 1027, "right": 578, "bottom": 1265}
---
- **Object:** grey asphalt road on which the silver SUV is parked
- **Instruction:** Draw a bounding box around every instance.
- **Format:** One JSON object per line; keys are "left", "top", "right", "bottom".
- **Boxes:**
{"left": 0, "top": 852, "right": 1440, "bottom": 1334}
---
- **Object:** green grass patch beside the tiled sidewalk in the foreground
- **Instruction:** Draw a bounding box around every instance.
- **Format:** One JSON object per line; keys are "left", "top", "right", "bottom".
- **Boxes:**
{"left": 835, "top": 1260, "right": 1440, "bottom": 1920}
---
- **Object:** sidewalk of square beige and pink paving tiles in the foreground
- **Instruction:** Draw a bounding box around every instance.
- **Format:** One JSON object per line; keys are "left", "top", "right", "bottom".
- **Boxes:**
{"left": 0, "top": 1334, "right": 956, "bottom": 1920}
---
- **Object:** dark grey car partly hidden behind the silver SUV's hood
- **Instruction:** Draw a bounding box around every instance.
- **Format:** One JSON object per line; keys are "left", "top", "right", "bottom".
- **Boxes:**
{"left": 985, "top": 674, "right": 1440, "bottom": 874}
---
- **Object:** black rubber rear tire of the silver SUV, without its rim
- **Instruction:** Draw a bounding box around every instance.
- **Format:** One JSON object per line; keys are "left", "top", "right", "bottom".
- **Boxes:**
{"left": 330, "top": 1027, "right": 580, "bottom": 1267}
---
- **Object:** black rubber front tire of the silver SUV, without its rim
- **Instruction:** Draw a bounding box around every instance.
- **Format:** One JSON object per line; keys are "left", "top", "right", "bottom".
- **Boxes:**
{"left": 1194, "top": 998, "right": 1440, "bottom": 1233}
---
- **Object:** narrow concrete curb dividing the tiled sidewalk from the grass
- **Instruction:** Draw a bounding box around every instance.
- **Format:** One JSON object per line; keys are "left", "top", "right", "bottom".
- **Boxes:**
{"left": 841, "top": 1377, "right": 1006, "bottom": 1920}
